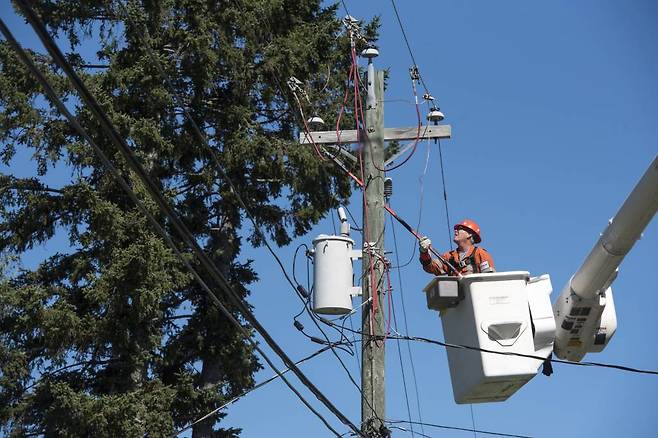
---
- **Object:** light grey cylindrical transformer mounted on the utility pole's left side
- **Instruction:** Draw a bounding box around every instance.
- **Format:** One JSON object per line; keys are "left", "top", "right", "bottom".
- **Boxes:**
{"left": 313, "top": 234, "right": 354, "bottom": 315}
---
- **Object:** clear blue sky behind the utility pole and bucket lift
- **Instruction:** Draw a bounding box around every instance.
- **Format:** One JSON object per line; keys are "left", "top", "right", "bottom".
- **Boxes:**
{"left": 1, "top": 0, "right": 658, "bottom": 437}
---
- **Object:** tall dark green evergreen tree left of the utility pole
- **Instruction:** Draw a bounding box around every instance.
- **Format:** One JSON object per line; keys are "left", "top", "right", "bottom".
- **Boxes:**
{"left": 0, "top": 0, "right": 377, "bottom": 437}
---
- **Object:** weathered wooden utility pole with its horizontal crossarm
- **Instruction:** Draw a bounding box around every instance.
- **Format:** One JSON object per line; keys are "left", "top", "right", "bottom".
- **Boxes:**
{"left": 299, "top": 48, "right": 451, "bottom": 438}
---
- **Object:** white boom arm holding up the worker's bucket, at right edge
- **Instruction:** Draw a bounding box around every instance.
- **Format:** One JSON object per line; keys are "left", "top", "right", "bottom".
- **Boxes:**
{"left": 553, "top": 156, "right": 658, "bottom": 361}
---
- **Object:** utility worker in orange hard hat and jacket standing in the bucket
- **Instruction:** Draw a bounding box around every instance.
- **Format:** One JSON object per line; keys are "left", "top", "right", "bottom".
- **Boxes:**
{"left": 419, "top": 219, "right": 495, "bottom": 275}
